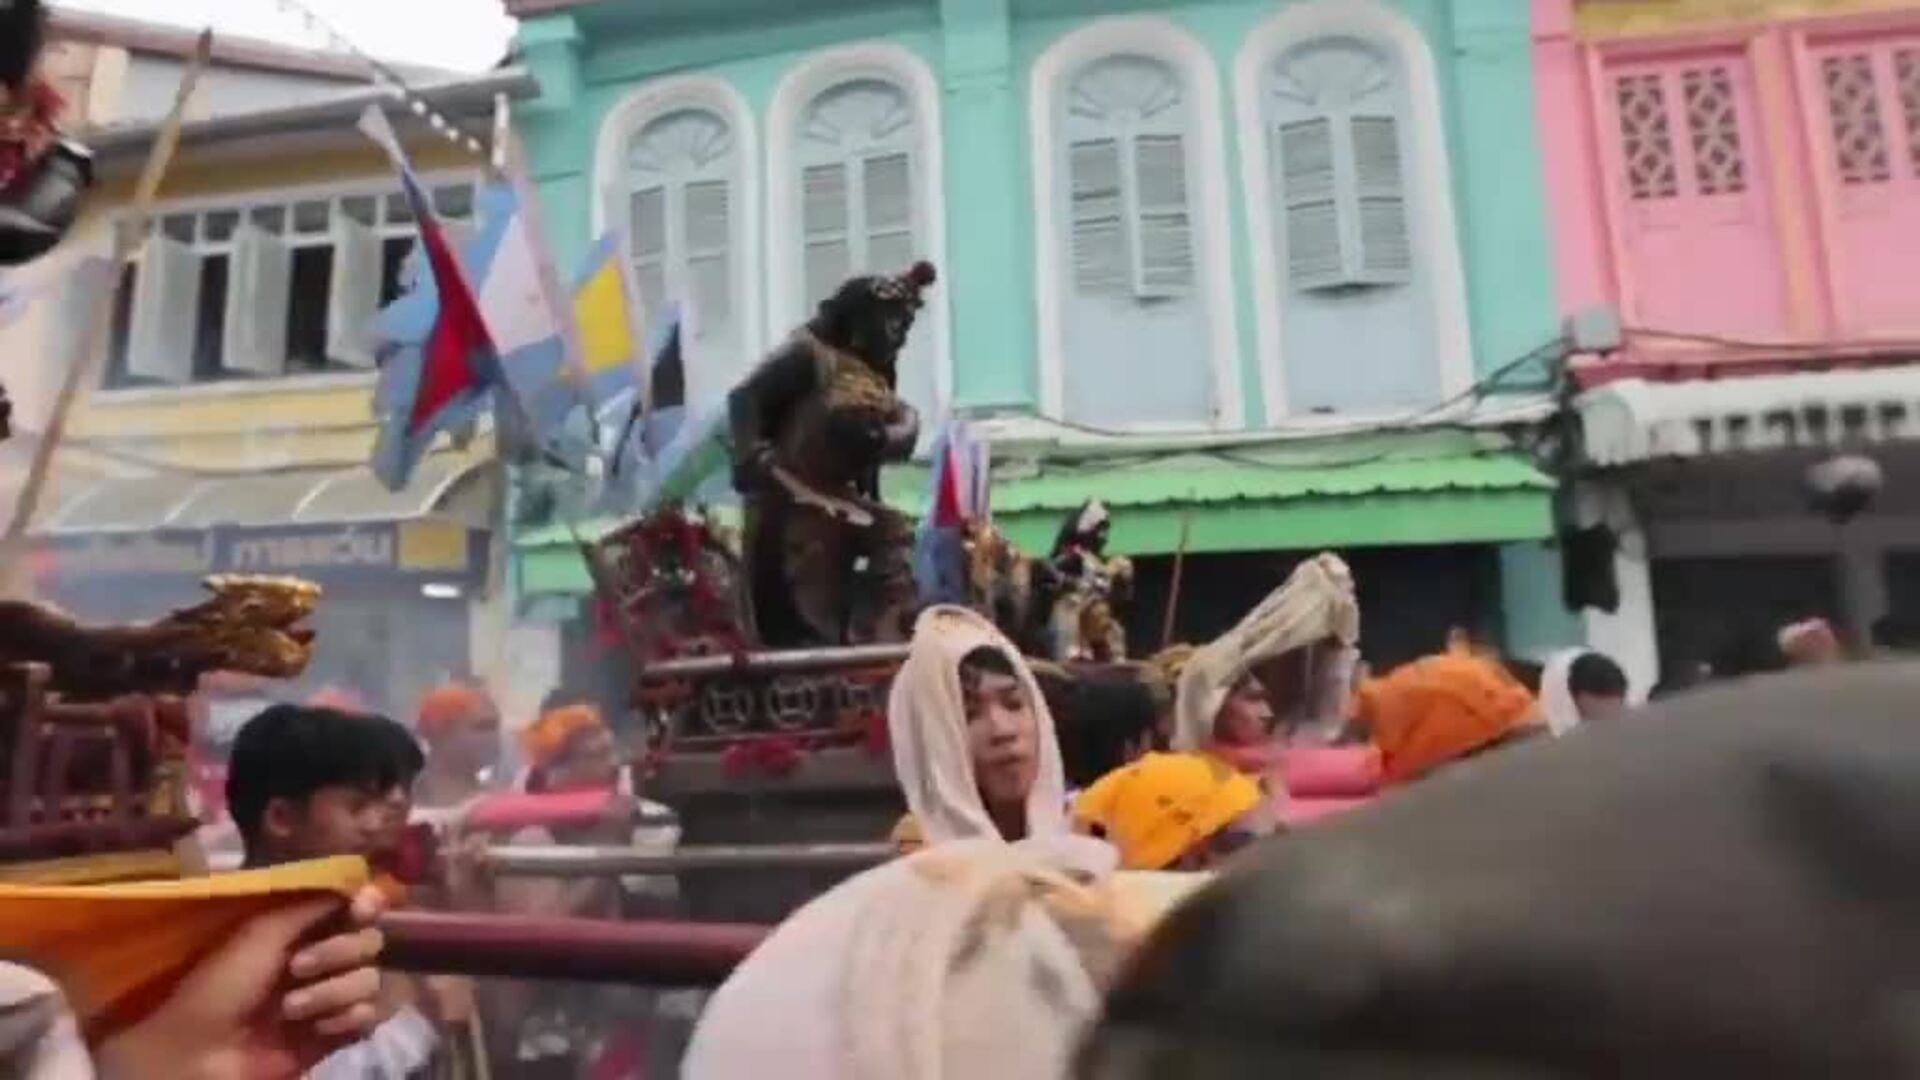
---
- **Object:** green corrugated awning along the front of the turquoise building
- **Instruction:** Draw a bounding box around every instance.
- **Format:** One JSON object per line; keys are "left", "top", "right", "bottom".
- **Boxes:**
{"left": 515, "top": 432, "right": 1553, "bottom": 594}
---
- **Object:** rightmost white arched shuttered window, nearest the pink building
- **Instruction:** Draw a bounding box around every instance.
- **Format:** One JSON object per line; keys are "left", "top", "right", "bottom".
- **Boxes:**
{"left": 1236, "top": 0, "right": 1473, "bottom": 421}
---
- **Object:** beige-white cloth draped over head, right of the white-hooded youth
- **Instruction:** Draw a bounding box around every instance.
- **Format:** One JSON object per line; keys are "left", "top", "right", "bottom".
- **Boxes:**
{"left": 1173, "top": 553, "right": 1359, "bottom": 751}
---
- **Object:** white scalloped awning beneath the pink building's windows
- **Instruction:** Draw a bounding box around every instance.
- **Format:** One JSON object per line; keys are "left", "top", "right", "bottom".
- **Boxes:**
{"left": 1578, "top": 367, "right": 1920, "bottom": 467}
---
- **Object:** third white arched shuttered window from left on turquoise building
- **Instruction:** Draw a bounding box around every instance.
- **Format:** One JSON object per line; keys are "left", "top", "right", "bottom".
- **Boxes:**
{"left": 1033, "top": 19, "right": 1240, "bottom": 427}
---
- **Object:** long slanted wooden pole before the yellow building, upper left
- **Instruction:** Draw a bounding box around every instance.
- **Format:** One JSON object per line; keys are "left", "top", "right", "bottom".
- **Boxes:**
{"left": 0, "top": 29, "right": 213, "bottom": 592}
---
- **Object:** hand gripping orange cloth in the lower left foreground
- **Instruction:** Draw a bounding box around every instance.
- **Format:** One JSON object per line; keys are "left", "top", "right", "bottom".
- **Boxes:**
{"left": 96, "top": 886, "right": 386, "bottom": 1080}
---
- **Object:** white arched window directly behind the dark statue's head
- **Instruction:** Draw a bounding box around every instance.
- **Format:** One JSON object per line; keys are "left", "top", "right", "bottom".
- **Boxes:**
{"left": 768, "top": 42, "right": 952, "bottom": 428}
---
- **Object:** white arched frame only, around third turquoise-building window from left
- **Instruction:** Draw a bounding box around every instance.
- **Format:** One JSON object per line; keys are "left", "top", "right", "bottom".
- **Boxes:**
{"left": 1027, "top": 15, "right": 1246, "bottom": 429}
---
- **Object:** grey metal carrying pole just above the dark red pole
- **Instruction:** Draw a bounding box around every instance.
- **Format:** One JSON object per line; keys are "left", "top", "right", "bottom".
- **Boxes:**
{"left": 488, "top": 844, "right": 899, "bottom": 878}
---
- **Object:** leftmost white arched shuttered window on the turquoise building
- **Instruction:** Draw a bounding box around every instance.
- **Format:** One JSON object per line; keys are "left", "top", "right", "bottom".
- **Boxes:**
{"left": 595, "top": 79, "right": 760, "bottom": 400}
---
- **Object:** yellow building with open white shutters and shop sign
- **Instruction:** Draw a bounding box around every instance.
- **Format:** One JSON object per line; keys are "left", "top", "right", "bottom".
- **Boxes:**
{"left": 8, "top": 54, "right": 534, "bottom": 715}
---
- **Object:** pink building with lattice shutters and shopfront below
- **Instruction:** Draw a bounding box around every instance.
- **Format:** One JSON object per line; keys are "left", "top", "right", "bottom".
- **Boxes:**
{"left": 1534, "top": 0, "right": 1920, "bottom": 675}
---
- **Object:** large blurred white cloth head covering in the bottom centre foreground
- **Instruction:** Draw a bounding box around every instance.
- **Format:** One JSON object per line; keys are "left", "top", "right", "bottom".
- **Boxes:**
{"left": 682, "top": 836, "right": 1128, "bottom": 1080}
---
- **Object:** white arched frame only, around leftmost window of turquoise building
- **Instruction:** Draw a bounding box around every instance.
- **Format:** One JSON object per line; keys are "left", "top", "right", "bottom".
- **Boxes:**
{"left": 589, "top": 75, "right": 768, "bottom": 390}
